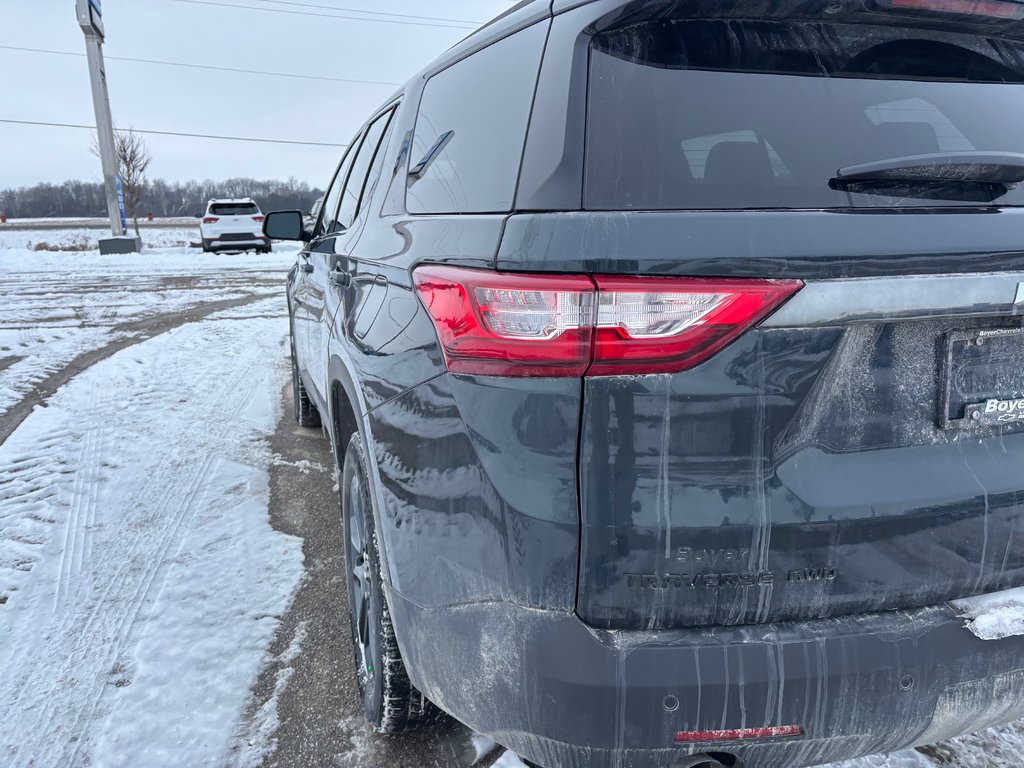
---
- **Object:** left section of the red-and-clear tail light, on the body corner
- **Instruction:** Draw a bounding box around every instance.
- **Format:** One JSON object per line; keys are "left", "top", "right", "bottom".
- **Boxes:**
{"left": 414, "top": 266, "right": 594, "bottom": 377}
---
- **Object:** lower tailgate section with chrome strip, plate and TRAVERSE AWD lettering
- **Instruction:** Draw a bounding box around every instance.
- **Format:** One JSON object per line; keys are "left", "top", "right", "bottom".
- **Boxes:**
{"left": 579, "top": 273, "right": 1024, "bottom": 628}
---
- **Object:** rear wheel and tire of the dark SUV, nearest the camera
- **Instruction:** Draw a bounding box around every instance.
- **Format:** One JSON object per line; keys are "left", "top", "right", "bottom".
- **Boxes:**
{"left": 341, "top": 432, "right": 441, "bottom": 733}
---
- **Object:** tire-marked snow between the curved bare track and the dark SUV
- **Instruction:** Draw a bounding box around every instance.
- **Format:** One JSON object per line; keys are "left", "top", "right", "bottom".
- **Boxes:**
{"left": 0, "top": 309, "right": 302, "bottom": 767}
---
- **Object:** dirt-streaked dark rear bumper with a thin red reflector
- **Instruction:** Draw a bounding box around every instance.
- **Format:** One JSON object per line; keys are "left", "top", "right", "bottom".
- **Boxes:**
{"left": 388, "top": 591, "right": 1024, "bottom": 768}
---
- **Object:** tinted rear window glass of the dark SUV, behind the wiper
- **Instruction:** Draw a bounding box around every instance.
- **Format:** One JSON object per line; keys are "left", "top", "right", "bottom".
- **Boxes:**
{"left": 585, "top": 20, "right": 1024, "bottom": 210}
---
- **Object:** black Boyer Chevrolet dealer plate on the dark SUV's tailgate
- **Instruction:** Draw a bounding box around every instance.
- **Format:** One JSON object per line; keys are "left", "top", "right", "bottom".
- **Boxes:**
{"left": 939, "top": 328, "right": 1024, "bottom": 429}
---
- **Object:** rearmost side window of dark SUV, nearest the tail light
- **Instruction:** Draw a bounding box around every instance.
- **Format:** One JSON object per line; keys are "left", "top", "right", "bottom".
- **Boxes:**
{"left": 406, "top": 23, "right": 547, "bottom": 213}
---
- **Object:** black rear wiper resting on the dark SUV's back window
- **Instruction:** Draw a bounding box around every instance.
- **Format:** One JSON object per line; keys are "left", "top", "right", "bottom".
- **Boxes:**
{"left": 828, "top": 152, "right": 1024, "bottom": 203}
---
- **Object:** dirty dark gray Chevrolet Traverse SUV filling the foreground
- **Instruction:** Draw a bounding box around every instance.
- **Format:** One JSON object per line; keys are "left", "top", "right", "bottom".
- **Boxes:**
{"left": 265, "top": 0, "right": 1024, "bottom": 768}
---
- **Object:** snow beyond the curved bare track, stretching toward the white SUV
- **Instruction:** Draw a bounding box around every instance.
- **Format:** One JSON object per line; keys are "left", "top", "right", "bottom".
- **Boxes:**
{"left": 0, "top": 239, "right": 295, "bottom": 423}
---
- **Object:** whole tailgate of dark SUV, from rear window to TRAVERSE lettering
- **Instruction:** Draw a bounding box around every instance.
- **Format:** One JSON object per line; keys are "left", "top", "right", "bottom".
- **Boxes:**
{"left": 565, "top": 7, "right": 1024, "bottom": 628}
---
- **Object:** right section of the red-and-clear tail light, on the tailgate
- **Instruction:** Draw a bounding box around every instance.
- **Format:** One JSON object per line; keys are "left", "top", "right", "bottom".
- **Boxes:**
{"left": 587, "top": 276, "right": 803, "bottom": 376}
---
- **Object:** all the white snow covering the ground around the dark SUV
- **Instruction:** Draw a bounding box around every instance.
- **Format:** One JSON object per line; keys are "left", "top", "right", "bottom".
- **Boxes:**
{"left": 0, "top": 229, "right": 1024, "bottom": 768}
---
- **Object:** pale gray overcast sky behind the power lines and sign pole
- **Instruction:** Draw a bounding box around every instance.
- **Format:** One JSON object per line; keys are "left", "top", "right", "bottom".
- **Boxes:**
{"left": 0, "top": 0, "right": 514, "bottom": 188}
